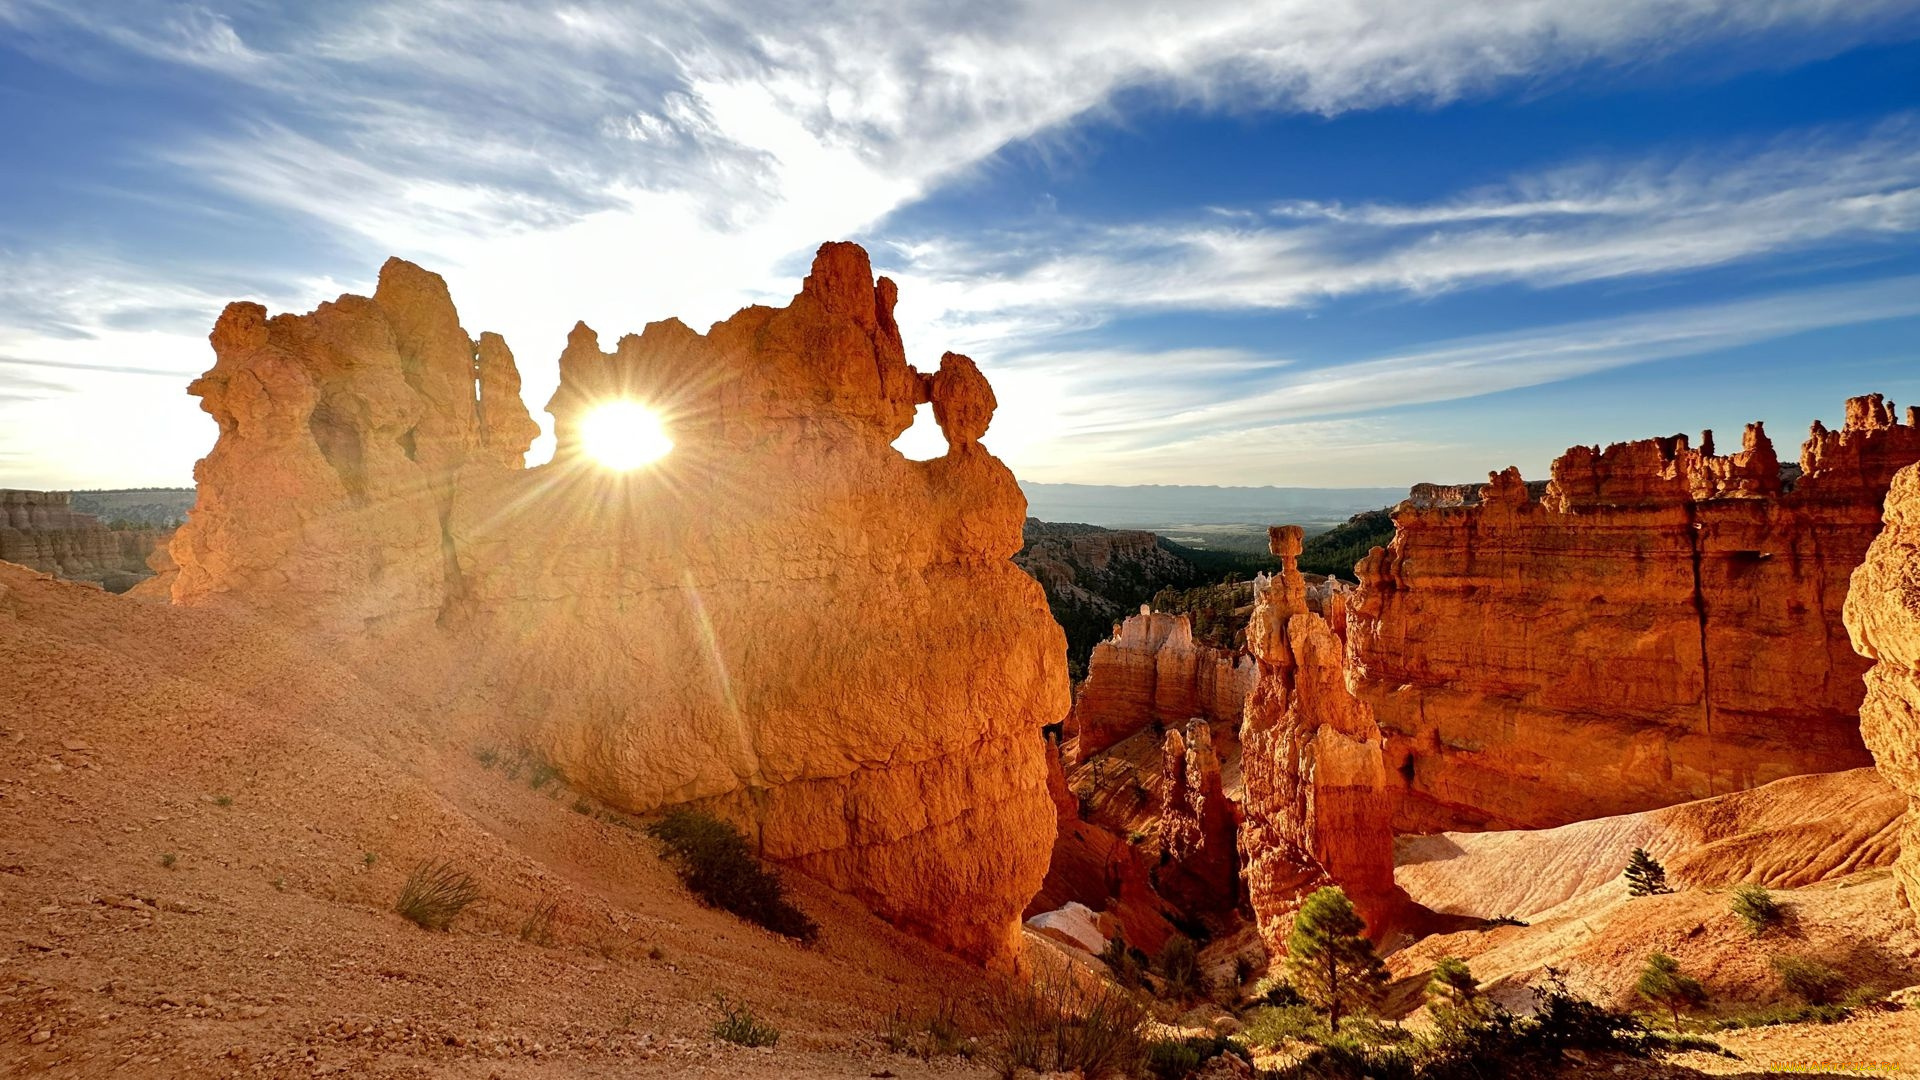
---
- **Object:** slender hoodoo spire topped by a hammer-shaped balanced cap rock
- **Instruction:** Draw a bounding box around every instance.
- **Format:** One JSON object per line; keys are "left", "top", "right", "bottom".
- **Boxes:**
{"left": 1240, "top": 525, "right": 1407, "bottom": 955}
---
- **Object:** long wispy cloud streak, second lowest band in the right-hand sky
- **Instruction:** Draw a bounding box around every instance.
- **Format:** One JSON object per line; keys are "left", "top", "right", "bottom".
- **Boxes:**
{"left": 904, "top": 117, "right": 1920, "bottom": 334}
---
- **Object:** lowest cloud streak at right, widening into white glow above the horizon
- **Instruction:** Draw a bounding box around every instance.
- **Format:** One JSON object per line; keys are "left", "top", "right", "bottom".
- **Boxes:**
{"left": 989, "top": 277, "right": 1920, "bottom": 484}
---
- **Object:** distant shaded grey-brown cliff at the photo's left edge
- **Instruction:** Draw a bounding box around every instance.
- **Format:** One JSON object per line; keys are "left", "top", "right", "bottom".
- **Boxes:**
{"left": 0, "top": 488, "right": 167, "bottom": 592}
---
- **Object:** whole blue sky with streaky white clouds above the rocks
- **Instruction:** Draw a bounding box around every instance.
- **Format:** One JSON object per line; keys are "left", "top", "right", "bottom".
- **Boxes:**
{"left": 0, "top": 0, "right": 1920, "bottom": 488}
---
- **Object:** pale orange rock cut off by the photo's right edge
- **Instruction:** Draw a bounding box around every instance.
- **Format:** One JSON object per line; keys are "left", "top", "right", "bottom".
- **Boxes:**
{"left": 1841, "top": 457, "right": 1920, "bottom": 915}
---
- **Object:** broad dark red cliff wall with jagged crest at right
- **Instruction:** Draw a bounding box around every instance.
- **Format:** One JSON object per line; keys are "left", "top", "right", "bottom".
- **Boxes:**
{"left": 1348, "top": 396, "right": 1920, "bottom": 832}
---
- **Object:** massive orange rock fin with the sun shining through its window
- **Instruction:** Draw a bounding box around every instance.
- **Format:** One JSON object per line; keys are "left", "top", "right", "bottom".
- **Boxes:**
{"left": 159, "top": 244, "right": 1069, "bottom": 957}
